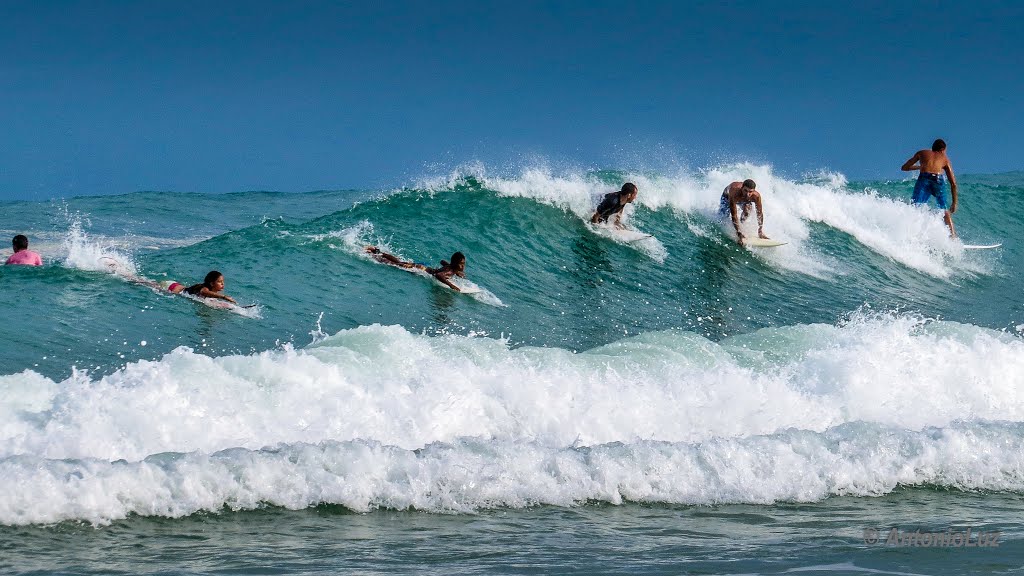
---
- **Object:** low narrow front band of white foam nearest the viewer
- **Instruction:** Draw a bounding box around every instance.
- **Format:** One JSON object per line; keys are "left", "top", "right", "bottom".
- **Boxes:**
{"left": 0, "top": 423, "right": 1024, "bottom": 525}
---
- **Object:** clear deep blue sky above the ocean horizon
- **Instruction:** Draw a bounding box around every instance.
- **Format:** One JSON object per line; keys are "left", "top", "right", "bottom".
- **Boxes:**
{"left": 0, "top": 1, "right": 1024, "bottom": 199}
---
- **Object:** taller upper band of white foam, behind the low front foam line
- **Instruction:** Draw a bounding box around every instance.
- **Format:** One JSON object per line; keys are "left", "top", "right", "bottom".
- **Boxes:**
{"left": 0, "top": 316, "right": 1024, "bottom": 460}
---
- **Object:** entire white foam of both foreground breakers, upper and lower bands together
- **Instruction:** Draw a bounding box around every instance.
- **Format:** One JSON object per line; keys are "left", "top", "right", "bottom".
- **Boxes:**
{"left": 0, "top": 313, "right": 1024, "bottom": 524}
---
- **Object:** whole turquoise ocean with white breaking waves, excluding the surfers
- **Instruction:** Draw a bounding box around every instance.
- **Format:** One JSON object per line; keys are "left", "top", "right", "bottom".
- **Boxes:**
{"left": 0, "top": 164, "right": 1024, "bottom": 575}
